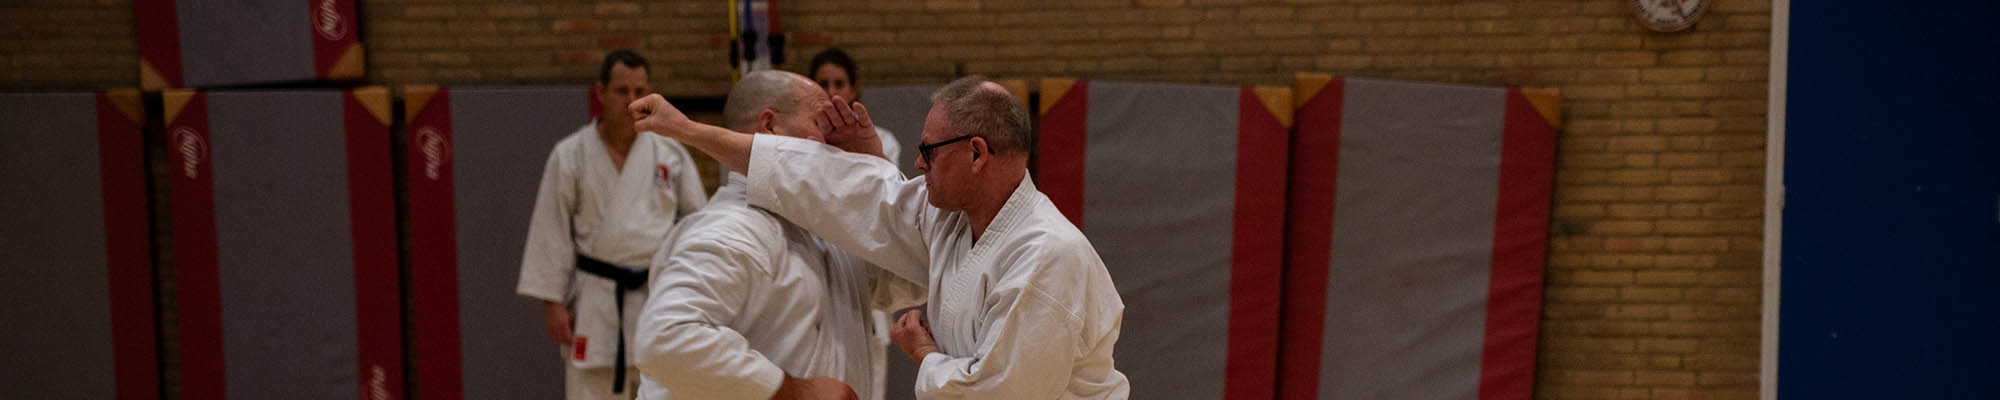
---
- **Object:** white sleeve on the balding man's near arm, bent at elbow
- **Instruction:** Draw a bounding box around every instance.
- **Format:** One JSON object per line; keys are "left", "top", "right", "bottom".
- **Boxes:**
{"left": 634, "top": 220, "right": 784, "bottom": 400}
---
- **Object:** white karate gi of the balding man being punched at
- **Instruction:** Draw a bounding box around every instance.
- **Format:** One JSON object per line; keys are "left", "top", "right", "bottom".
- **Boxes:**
{"left": 634, "top": 174, "right": 924, "bottom": 400}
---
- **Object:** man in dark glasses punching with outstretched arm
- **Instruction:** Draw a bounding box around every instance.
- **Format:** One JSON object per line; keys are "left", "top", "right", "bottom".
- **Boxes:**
{"left": 630, "top": 76, "right": 1130, "bottom": 398}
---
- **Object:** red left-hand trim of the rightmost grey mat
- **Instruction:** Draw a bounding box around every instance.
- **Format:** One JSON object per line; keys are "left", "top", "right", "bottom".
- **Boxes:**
{"left": 1278, "top": 78, "right": 1346, "bottom": 398}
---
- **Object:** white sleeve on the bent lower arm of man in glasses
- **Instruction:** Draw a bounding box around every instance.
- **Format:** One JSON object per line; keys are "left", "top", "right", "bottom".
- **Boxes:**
{"left": 916, "top": 274, "right": 1082, "bottom": 400}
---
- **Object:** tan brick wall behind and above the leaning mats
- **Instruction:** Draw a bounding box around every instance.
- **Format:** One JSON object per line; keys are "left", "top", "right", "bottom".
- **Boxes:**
{"left": 0, "top": 0, "right": 1770, "bottom": 398}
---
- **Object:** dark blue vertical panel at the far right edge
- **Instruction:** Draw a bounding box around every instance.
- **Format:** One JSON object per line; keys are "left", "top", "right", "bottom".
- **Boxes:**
{"left": 1766, "top": 0, "right": 2000, "bottom": 398}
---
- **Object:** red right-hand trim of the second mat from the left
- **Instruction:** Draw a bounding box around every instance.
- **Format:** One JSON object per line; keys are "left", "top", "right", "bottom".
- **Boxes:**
{"left": 340, "top": 92, "right": 402, "bottom": 400}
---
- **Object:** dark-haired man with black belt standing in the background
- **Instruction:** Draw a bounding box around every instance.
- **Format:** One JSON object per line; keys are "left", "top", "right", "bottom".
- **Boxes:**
{"left": 516, "top": 50, "right": 708, "bottom": 400}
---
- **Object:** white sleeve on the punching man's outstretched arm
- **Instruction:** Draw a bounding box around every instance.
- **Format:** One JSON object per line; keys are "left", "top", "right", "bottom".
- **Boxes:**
{"left": 748, "top": 134, "right": 932, "bottom": 282}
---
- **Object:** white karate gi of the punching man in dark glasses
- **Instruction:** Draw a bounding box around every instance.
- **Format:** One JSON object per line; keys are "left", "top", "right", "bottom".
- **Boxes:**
{"left": 748, "top": 134, "right": 1130, "bottom": 398}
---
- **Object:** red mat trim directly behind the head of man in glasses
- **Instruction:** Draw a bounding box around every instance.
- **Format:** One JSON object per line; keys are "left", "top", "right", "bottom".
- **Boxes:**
{"left": 1034, "top": 80, "right": 1090, "bottom": 230}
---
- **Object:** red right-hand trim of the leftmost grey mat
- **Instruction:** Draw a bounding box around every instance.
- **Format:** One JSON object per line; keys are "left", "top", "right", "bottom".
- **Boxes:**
{"left": 96, "top": 92, "right": 160, "bottom": 400}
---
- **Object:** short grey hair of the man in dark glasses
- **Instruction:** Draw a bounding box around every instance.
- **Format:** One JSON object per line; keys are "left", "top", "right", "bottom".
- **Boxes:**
{"left": 930, "top": 76, "right": 1034, "bottom": 152}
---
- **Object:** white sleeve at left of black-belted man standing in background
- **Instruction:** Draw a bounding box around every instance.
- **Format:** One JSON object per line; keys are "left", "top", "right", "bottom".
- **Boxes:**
{"left": 514, "top": 144, "right": 576, "bottom": 302}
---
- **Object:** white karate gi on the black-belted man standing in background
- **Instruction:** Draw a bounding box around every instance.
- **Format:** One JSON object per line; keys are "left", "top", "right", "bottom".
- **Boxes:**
{"left": 516, "top": 122, "right": 708, "bottom": 400}
